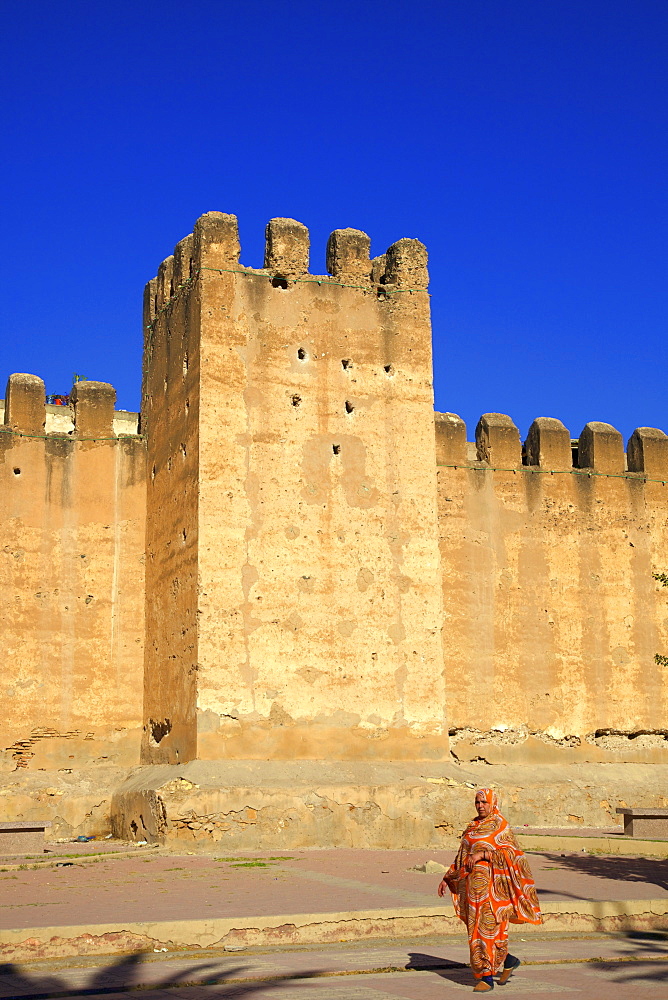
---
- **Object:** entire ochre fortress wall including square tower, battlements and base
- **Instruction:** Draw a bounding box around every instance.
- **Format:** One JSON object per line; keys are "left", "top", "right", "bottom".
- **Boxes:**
{"left": 0, "top": 212, "right": 668, "bottom": 848}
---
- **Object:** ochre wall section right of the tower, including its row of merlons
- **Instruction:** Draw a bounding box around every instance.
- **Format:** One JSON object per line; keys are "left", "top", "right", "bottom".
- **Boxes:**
{"left": 436, "top": 414, "right": 668, "bottom": 763}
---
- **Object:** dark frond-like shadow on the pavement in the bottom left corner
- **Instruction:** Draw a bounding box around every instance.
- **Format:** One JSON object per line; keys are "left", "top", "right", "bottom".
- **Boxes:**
{"left": 0, "top": 952, "right": 321, "bottom": 1000}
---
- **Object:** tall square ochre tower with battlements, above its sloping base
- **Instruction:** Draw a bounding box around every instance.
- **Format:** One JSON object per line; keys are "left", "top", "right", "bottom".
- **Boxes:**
{"left": 145, "top": 213, "right": 447, "bottom": 762}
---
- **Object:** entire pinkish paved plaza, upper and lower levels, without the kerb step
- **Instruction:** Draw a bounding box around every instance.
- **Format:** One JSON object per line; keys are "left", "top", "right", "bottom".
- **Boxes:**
{"left": 0, "top": 843, "right": 668, "bottom": 1000}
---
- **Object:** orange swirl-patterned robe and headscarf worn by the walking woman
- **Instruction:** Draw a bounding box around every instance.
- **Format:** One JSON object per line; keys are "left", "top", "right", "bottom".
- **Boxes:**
{"left": 444, "top": 788, "right": 543, "bottom": 979}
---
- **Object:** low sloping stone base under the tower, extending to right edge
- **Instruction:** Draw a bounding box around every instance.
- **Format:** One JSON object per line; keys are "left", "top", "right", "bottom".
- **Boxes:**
{"left": 111, "top": 761, "right": 668, "bottom": 852}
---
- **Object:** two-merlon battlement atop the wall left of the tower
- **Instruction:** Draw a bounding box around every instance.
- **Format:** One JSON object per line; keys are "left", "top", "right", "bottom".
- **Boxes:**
{"left": 0, "top": 372, "right": 139, "bottom": 441}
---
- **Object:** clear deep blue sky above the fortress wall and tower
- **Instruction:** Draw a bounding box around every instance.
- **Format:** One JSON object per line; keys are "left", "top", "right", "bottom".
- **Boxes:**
{"left": 0, "top": 0, "right": 668, "bottom": 436}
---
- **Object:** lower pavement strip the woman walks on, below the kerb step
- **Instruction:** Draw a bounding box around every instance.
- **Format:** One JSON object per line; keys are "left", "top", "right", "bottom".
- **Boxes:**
{"left": 0, "top": 933, "right": 668, "bottom": 1000}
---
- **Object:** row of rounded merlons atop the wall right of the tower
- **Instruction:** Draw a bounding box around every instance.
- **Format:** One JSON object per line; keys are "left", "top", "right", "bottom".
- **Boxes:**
{"left": 435, "top": 413, "right": 668, "bottom": 482}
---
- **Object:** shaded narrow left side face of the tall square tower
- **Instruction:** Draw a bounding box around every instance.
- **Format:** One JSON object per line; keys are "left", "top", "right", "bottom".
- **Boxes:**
{"left": 142, "top": 238, "right": 200, "bottom": 763}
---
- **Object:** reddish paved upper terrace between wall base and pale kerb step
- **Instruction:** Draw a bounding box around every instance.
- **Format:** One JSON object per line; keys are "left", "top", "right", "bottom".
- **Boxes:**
{"left": 0, "top": 848, "right": 668, "bottom": 929}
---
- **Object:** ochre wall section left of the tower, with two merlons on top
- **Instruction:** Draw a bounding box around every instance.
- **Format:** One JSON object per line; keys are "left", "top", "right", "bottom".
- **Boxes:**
{"left": 0, "top": 375, "right": 146, "bottom": 771}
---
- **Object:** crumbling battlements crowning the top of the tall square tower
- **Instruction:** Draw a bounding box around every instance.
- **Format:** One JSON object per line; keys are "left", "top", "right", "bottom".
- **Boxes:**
{"left": 144, "top": 212, "right": 429, "bottom": 327}
